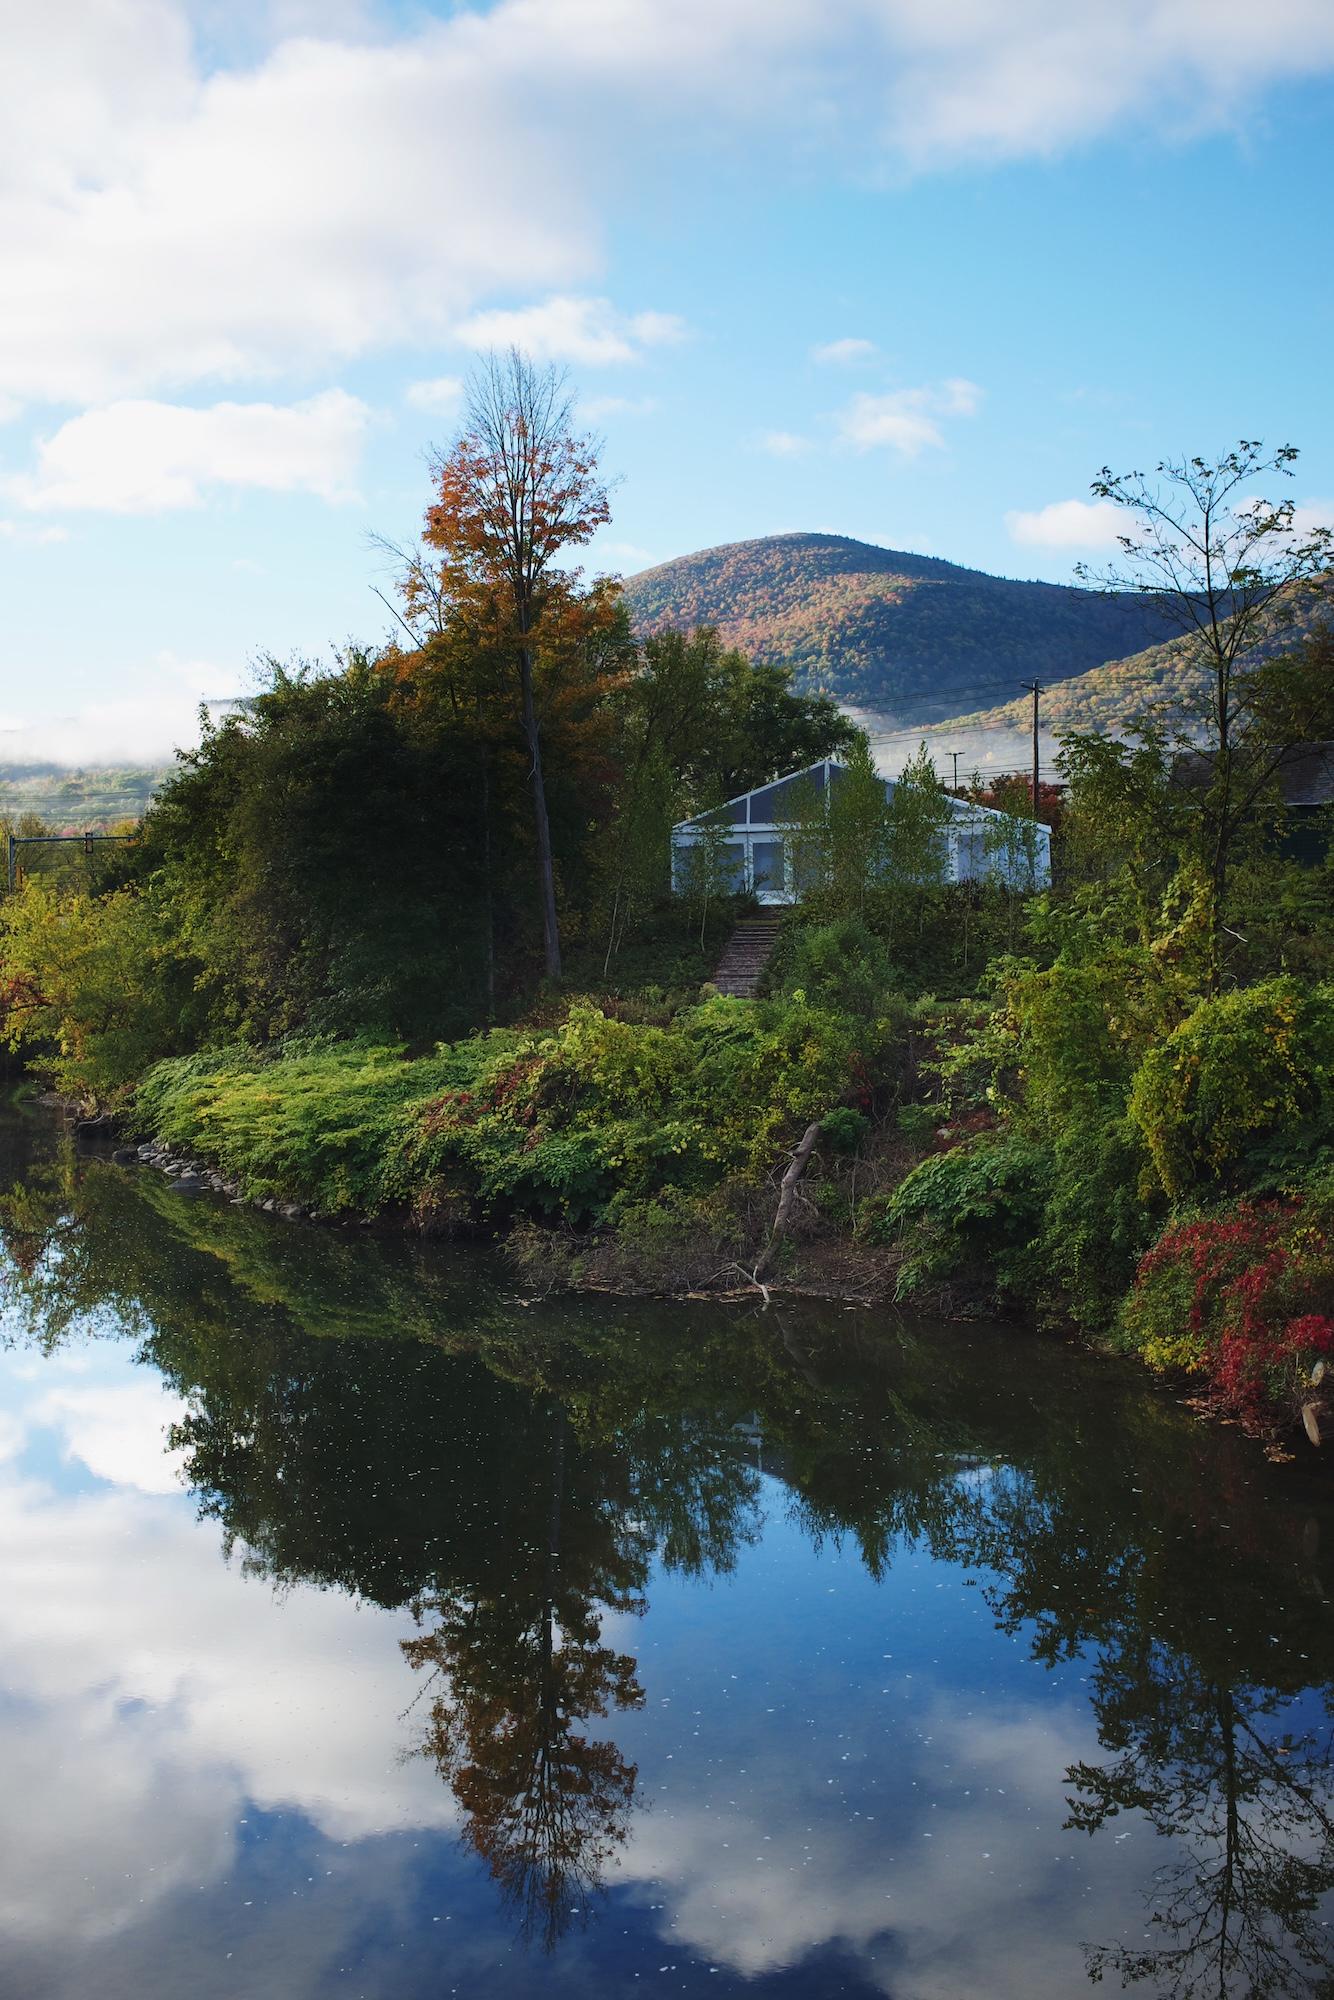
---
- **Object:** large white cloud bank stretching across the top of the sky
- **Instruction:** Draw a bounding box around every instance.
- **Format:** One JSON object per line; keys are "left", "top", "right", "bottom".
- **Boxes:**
{"left": 0, "top": 0, "right": 1334, "bottom": 404}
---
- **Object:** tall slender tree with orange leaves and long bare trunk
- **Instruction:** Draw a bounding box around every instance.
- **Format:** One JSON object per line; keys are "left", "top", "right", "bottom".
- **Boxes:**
{"left": 424, "top": 348, "right": 610, "bottom": 978}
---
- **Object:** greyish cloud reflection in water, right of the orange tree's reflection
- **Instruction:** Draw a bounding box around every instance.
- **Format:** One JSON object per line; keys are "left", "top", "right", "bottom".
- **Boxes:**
{"left": 616, "top": 1696, "right": 1142, "bottom": 2000}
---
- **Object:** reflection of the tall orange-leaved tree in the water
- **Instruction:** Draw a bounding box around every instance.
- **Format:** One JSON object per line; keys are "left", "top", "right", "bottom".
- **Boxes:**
{"left": 404, "top": 1412, "right": 644, "bottom": 1950}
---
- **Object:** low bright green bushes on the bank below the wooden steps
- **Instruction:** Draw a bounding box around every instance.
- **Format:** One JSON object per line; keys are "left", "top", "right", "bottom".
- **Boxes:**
{"left": 134, "top": 998, "right": 864, "bottom": 1228}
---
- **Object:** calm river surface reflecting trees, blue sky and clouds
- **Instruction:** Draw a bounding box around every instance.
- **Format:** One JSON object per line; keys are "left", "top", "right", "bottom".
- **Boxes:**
{"left": 0, "top": 1112, "right": 1334, "bottom": 2000}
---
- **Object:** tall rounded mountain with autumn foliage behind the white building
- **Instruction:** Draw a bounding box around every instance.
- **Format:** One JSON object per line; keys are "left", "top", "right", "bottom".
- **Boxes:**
{"left": 626, "top": 534, "right": 1166, "bottom": 722}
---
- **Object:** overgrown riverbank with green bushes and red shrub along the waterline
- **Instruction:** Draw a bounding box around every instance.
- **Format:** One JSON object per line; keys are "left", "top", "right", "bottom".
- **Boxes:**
{"left": 44, "top": 982, "right": 1334, "bottom": 1444}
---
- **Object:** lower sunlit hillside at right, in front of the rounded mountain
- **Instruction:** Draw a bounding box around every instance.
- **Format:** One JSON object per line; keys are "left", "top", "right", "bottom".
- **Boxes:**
{"left": 928, "top": 576, "right": 1334, "bottom": 752}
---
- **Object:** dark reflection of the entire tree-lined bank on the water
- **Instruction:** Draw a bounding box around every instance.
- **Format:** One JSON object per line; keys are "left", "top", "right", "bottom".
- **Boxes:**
{"left": 0, "top": 1128, "right": 1334, "bottom": 2000}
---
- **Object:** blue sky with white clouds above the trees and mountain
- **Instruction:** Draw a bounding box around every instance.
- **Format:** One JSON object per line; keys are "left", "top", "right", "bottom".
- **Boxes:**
{"left": 0, "top": 0, "right": 1334, "bottom": 762}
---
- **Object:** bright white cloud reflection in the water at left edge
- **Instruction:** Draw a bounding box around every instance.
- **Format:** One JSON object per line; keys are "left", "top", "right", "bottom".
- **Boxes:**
{"left": 0, "top": 1408, "right": 458, "bottom": 1938}
